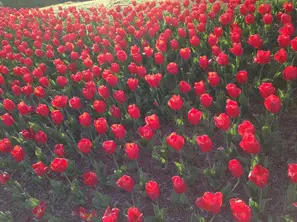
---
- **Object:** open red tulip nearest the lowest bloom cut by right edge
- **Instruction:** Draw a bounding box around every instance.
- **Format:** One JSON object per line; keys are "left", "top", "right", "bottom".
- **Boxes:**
{"left": 249, "top": 164, "right": 269, "bottom": 188}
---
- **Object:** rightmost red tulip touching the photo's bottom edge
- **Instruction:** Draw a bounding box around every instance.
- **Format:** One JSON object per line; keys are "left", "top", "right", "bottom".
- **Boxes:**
{"left": 229, "top": 198, "right": 252, "bottom": 222}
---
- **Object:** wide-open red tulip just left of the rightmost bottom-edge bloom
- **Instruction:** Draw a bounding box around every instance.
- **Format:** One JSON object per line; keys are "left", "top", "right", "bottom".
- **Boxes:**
{"left": 195, "top": 192, "right": 223, "bottom": 214}
